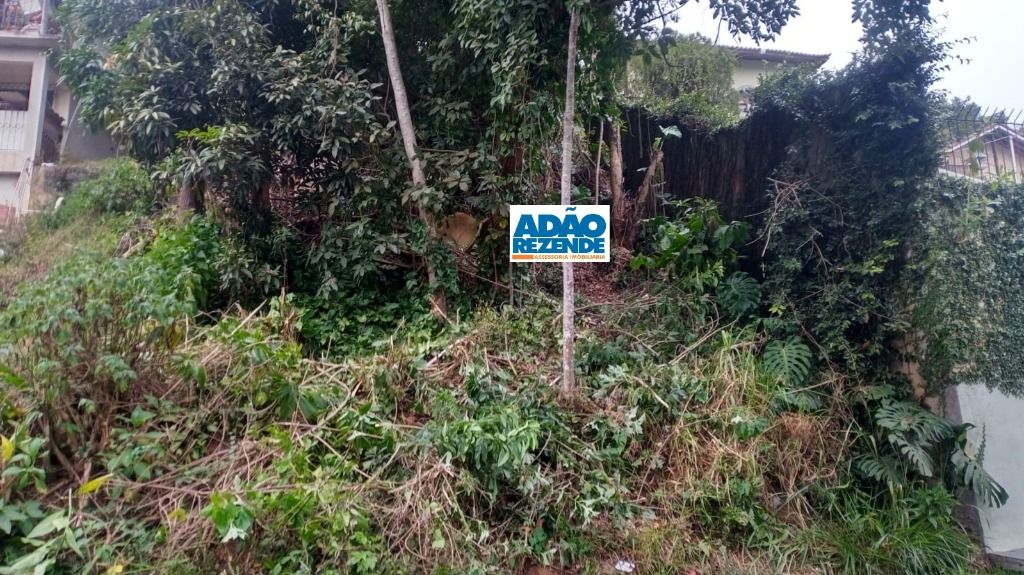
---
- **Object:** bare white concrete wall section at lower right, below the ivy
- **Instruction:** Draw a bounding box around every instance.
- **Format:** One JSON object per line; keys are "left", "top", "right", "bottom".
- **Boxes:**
{"left": 950, "top": 386, "right": 1024, "bottom": 552}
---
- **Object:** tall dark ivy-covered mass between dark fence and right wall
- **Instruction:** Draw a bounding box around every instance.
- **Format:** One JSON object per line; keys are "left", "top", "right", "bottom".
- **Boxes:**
{"left": 757, "top": 0, "right": 1003, "bottom": 504}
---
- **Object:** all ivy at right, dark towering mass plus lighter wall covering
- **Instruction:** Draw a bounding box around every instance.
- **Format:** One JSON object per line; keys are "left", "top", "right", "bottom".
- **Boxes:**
{"left": 755, "top": 1, "right": 1024, "bottom": 497}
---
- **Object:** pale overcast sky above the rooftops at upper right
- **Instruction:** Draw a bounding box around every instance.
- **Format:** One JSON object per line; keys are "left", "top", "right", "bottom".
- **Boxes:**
{"left": 675, "top": 0, "right": 1024, "bottom": 110}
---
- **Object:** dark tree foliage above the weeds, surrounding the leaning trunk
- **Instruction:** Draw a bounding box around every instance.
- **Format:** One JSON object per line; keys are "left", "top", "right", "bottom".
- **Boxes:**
{"left": 60, "top": 0, "right": 796, "bottom": 302}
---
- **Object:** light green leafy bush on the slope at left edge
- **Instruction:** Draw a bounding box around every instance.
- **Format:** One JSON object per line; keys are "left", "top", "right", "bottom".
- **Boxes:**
{"left": 0, "top": 214, "right": 217, "bottom": 471}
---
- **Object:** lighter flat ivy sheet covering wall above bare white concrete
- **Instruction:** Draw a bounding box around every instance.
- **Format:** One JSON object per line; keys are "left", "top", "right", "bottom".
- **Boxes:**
{"left": 907, "top": 178, "right": 1024, "bottom": 395}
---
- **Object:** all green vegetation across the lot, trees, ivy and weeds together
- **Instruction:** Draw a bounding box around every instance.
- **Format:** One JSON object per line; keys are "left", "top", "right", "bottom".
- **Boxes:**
{"left": 0, "top": 0, "right": 1024, "bottom": 575}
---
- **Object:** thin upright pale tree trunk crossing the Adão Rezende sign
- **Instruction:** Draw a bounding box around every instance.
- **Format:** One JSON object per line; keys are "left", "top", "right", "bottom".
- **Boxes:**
{"left": 561, "top": 8, "right": 580, "bottom": 394}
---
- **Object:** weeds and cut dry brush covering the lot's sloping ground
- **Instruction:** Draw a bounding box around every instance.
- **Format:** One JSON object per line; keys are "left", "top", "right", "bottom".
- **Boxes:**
{"left": 0, "top": 171, "right": 1015, "bottom": 574}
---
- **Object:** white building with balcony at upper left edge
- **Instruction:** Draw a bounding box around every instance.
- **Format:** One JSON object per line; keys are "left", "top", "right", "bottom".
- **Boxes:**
{"left": 0, "top": 0, "right": 114, "bottom": 223}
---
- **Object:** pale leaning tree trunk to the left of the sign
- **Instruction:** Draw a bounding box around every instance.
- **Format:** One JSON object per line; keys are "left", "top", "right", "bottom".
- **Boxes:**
{"left": 377, "top": 0, "right": 447, "bottom": 317}
